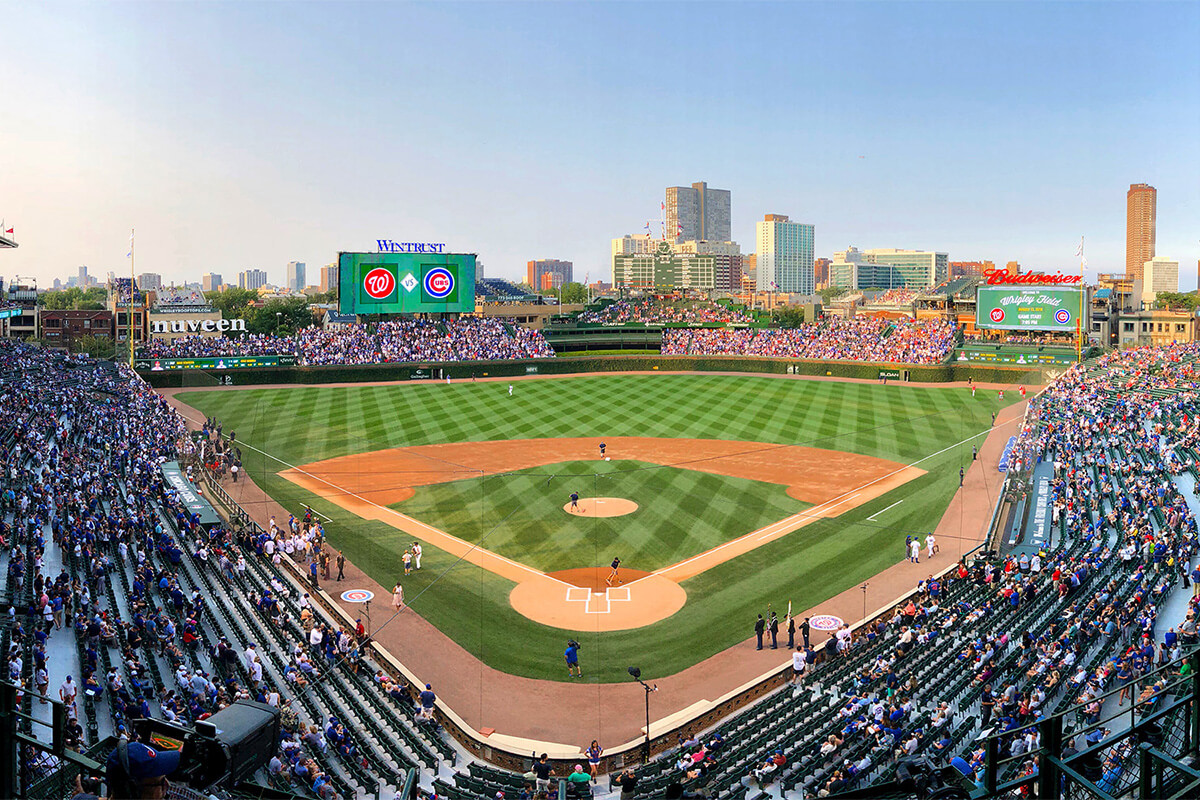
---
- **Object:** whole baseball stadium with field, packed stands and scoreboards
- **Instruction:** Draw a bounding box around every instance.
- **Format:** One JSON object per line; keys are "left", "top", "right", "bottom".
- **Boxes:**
{"left": 7, "top": 239, "right": 1200, "bottom": 800}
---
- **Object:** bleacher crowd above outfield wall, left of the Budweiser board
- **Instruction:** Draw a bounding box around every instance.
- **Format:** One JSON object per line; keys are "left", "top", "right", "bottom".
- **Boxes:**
{"left": 662, "top": 317, "right": 955, "bottom": 363}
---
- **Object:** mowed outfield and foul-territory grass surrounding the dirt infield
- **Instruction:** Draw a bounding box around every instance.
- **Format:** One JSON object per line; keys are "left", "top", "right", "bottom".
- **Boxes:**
{"left": 180, "top": 375, "right": 1016, "bottom": 681}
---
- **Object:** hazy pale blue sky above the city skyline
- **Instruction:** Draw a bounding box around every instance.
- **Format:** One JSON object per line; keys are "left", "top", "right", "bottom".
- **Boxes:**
{"left": 0, "top": 2, "right": 1200, "bottom": 288}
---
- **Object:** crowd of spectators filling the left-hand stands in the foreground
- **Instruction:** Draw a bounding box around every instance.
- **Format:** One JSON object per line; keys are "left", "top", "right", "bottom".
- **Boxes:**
{"left": 0, "top": 339, "right": 433, "bottom": 800}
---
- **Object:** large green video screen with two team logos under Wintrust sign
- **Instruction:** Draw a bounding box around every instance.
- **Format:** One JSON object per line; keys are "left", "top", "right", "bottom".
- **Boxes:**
{"left": 337, "top": 253, "right": 475, "bottom": 314}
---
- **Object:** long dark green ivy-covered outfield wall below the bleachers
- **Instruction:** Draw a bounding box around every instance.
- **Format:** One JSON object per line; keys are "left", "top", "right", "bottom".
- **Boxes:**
{"left": 140, "top": 355, "right": 1058, "bottom": 387}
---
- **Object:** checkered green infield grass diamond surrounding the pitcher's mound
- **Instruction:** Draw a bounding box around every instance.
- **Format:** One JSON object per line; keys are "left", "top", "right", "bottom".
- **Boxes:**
{"left": 391, "top": 461, "right": 811, "bottom": 572}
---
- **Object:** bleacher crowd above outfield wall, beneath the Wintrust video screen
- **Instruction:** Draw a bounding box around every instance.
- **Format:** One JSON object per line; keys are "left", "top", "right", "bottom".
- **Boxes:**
{"left": 133, "top": 317, "right": 554, "bottom": 365}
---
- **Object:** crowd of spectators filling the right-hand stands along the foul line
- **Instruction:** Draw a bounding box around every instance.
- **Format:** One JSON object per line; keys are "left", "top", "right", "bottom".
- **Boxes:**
{"left": 641, "top": 344, "right": 1200, "bottom": 796}
